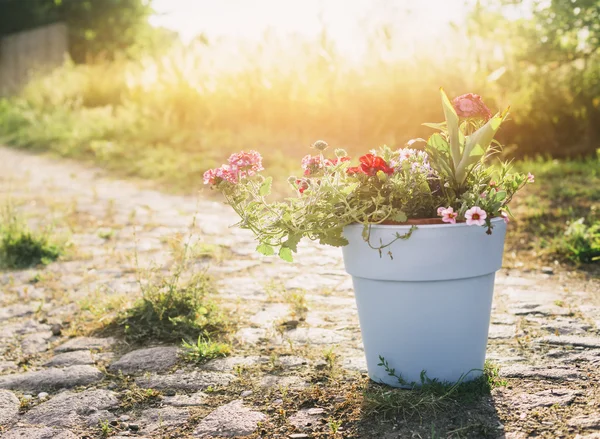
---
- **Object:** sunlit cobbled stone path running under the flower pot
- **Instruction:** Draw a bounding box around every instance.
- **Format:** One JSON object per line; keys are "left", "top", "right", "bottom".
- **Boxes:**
{"left": 0, "top": 149, "right": 600, "bottom": 439}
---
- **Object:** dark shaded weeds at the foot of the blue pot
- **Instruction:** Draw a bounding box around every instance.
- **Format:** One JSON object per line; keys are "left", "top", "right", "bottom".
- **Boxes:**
{"left": 364, "top": 359, "right": 506, "bottom": 420}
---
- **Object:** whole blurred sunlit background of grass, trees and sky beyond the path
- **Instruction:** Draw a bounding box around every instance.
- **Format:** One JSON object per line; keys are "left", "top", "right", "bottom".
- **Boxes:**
{"left": 0, "top": 0, "right": 600, "bottom": 266}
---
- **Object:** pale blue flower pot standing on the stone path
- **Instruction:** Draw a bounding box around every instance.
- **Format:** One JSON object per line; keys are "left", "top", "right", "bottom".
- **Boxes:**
{"left": 343, "top": 218, "right": 506, "bottom": 387}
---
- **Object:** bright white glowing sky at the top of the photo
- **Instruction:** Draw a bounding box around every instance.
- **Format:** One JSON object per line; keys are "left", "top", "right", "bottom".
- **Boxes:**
{"left": 151, "top": 0, "right": 473, "bottom": 55}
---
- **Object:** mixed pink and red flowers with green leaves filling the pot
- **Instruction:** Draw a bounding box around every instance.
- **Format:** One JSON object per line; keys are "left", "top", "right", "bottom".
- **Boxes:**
{"left": 204, "top": 89, "right": 534, "bottom": 261}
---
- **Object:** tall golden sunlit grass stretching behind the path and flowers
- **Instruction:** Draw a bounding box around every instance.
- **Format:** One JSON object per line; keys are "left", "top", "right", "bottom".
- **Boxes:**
{"left": 0, "top": 36, "right": 495, "bottom": 191}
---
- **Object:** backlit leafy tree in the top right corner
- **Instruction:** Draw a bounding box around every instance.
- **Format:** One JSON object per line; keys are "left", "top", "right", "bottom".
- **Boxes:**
{"left": 471, "top": 0, "right": 600, "bottom": 157}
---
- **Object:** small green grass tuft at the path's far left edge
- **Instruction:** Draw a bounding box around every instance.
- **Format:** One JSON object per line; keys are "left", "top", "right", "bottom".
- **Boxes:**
{"left": 0, "top": 208, "right": 63, "bottom": 269}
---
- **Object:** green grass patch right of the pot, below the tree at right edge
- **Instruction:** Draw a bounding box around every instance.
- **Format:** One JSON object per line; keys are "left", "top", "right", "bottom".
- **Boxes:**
{"left": 507, "top": 153, "right": 600, "bottom": 270}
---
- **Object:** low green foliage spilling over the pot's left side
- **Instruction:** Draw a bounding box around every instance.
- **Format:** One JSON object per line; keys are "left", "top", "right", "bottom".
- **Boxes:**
{"left": 215, "top": 147, "right": 437, "bottom": 262}
